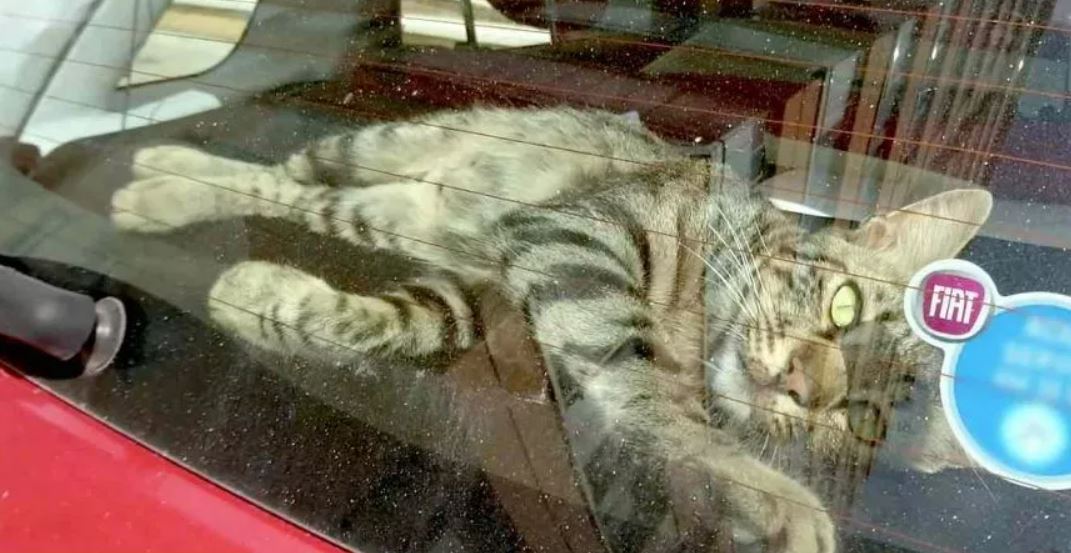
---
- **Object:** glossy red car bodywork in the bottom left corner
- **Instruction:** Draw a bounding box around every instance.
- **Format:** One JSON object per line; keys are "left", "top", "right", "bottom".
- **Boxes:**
{"left": 0, "top": 364, "right": 343, "bottom": 553}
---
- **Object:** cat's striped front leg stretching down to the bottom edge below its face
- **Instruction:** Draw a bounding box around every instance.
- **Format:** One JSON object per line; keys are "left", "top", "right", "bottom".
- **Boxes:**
{"left": 496, "top": 223, "right": 835, "bottom": 553}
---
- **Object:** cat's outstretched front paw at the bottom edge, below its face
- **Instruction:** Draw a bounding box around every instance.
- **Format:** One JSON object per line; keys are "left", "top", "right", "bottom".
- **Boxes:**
{"left": 724, "top": 461, "right": 836, "bottom": 553}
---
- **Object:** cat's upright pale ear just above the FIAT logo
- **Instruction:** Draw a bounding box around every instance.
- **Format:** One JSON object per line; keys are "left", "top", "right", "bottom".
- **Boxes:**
{"left": 850, "top": 190, "right": 993, "bottom": 267}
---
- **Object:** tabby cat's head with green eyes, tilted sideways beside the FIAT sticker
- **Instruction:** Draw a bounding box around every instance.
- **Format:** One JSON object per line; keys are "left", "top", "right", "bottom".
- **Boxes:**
{"left": 708, "top": 190, "right": 993, "bottom": 469}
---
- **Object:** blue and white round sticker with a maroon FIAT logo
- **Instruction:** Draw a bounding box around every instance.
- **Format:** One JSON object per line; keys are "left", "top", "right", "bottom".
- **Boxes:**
{"left": 904, "top": 259, "right": 1071, "bottom": 490}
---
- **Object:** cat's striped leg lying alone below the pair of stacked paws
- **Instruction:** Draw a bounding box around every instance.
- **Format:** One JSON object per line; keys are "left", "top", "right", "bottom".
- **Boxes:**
{"left": 208, "top": 261, "right": 476, "bottom": 360}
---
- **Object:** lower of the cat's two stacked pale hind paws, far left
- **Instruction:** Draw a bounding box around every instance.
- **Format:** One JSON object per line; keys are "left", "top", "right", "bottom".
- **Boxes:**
{"left": 111, "top": 175, "right": 218, "bottom": 233}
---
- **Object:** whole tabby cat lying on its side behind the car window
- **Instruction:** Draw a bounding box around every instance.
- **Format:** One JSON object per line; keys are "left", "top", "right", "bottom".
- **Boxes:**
{"left": 111, "top": 107, "right": 992, "bottom": 553}
